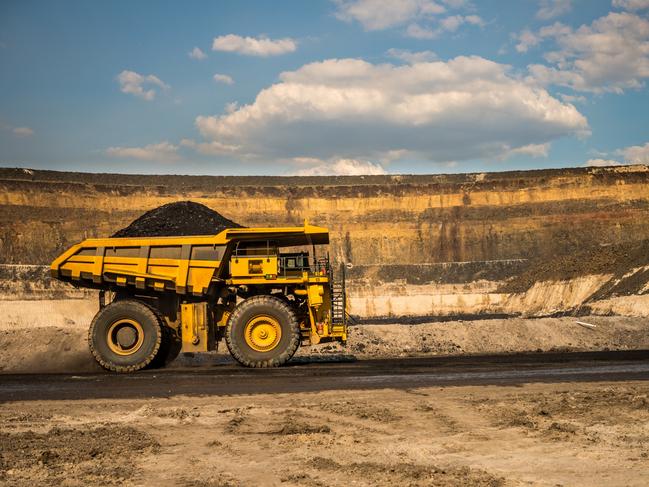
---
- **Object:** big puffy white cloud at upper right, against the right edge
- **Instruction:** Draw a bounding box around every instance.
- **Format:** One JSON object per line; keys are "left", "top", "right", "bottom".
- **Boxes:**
{"left": 529, "top": 12, "right": 649, "bottom": 93}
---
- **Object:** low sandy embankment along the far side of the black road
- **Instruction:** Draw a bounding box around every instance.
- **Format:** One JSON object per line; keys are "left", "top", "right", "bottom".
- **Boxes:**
{"left": 0, "top": 299, "right": 649, "bottom": 373}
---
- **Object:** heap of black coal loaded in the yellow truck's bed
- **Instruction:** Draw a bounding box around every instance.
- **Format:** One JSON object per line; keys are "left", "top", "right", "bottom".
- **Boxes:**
{"left": 113, "top": 201, "right": 241, "bottom": 237}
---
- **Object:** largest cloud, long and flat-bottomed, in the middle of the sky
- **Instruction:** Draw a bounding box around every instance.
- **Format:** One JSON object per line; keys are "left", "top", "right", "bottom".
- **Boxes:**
{"left": 191, "top": 56, "right": 588, "bottom": 167}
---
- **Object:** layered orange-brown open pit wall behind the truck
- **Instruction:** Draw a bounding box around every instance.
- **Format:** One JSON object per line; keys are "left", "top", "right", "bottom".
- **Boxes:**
{"left": 0, "top": 166, "right": 649, "bottom": 318}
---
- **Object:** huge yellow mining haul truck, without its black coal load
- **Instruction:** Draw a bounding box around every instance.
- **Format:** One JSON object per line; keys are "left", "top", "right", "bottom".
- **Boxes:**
{"left": 51, "top": 222, "right": 347, "bottom": 372}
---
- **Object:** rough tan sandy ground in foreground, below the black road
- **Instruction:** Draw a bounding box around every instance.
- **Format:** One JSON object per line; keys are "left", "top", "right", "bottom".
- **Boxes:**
{"left": 0, "top": 382, "right": 649, "bottom": 486}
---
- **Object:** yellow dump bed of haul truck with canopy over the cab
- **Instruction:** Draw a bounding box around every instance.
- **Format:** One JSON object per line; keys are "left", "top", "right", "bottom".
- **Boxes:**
{"left": 51, "top": 223, "right": 329, "bottom": 296}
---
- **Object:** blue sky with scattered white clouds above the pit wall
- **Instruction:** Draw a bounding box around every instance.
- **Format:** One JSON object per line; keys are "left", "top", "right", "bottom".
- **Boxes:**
{"left": 0, "top": 0, "right": 649, "bottom": 175}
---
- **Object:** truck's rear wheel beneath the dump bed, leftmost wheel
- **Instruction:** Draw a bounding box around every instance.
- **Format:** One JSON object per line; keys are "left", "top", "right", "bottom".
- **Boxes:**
{"left": 88, "top": 299, "right": 162, "bottom": 372}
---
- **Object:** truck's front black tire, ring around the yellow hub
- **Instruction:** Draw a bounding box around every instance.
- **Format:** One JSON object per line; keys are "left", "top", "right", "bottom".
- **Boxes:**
{"left": 225, "top": 296, "right": 300, "bottom": 367}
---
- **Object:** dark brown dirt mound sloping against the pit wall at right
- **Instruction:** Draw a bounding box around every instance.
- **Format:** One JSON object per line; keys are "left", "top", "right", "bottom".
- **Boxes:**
{"left": 498, "top": 240, "right": 649, "bottom": 298}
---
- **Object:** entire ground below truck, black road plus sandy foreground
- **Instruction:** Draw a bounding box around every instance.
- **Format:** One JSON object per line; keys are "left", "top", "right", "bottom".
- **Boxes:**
{"left": 0, "top": 351, "right": 649, "bottom": 487}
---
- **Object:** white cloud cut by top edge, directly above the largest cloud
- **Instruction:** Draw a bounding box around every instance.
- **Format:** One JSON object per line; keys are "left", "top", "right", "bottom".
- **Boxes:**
{"left": 334, "top": 0, "right": 446, "bottom": 30}
